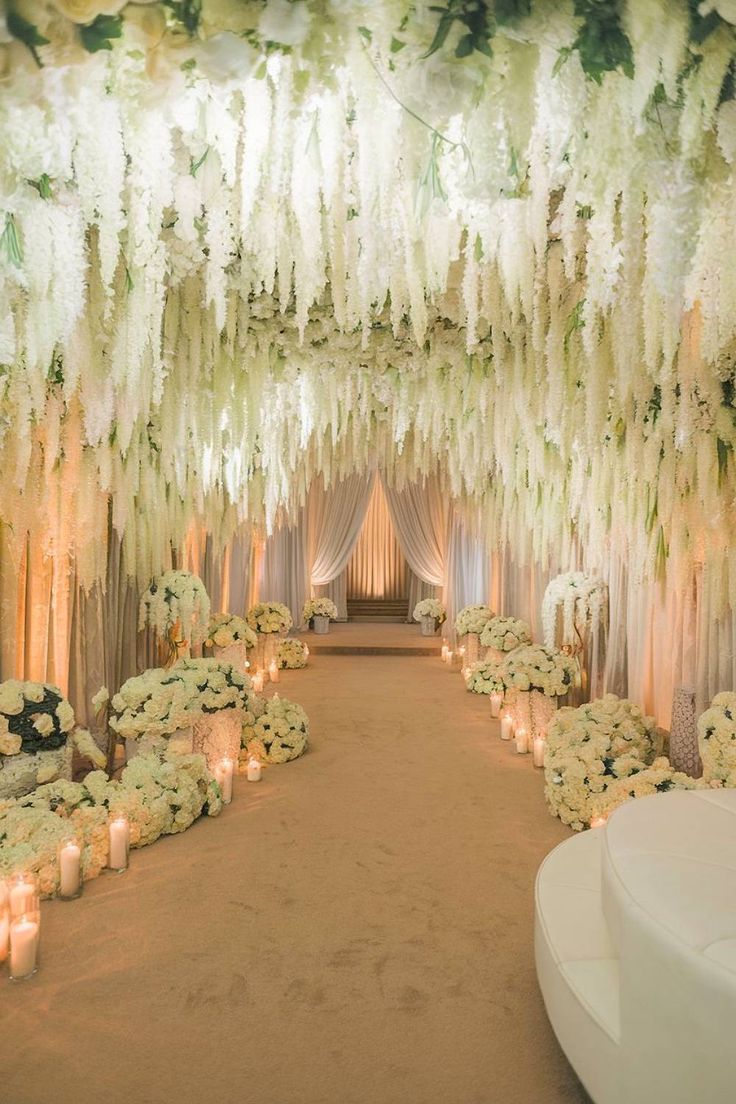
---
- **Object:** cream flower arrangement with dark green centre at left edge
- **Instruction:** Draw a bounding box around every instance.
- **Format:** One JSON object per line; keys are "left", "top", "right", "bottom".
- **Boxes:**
{"left": 0, "top": 679, "right": 105, "bottom": 797}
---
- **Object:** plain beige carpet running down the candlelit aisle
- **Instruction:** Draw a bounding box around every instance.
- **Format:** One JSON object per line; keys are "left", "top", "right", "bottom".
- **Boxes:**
{"left": 0, "top": 656, "right": 587, "bottom": 1104}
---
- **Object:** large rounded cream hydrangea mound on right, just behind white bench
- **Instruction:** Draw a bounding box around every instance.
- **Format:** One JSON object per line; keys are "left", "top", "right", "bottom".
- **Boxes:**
{"left": 544, "top": 694, "right": 662, "bottom": 831}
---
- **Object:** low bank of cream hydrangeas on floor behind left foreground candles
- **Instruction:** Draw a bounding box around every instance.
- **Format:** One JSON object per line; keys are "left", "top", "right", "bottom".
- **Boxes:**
{"left": 0, "top": 755, "right": 222, "bottom": 896}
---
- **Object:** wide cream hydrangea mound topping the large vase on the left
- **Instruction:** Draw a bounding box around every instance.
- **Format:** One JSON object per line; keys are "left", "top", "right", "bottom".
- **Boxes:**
{"left": 109, "top": 659, "right": 250, "bottom": 740}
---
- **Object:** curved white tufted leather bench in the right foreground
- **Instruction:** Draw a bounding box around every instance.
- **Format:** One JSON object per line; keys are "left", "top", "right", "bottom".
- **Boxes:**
{"left": 535, "top": 790, "right": 736, "bottom": 1104}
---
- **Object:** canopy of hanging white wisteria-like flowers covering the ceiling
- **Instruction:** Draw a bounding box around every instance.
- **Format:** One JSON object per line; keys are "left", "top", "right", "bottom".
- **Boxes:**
{"left": 0, "top": 0, "right": 736, "bottom": 607}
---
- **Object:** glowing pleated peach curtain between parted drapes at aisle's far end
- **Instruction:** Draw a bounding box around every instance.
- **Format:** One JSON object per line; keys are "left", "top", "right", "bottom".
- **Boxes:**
{"left": 346, "top": 479, "right": 408, "bottom": 601}
